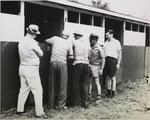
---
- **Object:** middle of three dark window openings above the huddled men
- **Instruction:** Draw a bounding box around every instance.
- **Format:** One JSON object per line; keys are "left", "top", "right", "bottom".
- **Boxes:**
{"left": 80, "top": 13, "right": 92, "bottom": 25}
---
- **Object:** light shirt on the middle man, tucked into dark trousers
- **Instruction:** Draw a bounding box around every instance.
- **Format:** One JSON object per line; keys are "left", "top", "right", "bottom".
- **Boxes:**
{"left": 73, "top": 38, "right": 90, "bottom": 65}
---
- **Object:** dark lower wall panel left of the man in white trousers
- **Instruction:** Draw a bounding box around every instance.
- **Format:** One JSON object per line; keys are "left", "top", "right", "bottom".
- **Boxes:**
{"left": 1, "top": 42, "right": 20, "bottom": 109}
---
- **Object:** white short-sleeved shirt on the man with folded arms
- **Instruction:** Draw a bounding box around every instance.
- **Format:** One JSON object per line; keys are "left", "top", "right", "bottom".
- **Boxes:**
{"left": 18, "top": 37, "right": 43, "bottom": 65}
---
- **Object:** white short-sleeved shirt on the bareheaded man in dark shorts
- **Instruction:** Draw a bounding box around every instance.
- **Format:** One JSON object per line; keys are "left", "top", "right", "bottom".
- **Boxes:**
{"left": 104, "top": 38, "right": 121, "bottom": 59}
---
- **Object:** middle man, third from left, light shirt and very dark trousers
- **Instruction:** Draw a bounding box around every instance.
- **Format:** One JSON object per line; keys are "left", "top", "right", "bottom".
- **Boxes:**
{"left": 73, "top": 32, "right": 90, "bottom": 108}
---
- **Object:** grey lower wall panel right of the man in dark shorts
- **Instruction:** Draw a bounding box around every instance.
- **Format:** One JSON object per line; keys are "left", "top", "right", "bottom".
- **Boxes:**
{"left": 122, "top": 46, "right": 145, "bottom": 81}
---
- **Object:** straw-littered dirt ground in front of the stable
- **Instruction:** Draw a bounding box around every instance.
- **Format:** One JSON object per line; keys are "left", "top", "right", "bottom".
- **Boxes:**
{"left": 0, "top": 80, "right": 150, "bottom": 120}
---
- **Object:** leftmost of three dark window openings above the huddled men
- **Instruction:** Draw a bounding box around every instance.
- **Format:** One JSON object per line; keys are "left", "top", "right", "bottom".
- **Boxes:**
{"left": 68, "top": 11, "right": 79, "bottom": 23}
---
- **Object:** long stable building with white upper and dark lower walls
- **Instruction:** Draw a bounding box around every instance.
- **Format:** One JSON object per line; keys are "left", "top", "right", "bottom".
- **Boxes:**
{"left": 0, "top": 0, "right": 150, "bottom": 109}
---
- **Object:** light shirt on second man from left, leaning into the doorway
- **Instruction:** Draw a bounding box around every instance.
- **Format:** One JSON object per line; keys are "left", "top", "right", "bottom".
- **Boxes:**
{"left": 46, "top": 36, "right": 73, "bottom": 64}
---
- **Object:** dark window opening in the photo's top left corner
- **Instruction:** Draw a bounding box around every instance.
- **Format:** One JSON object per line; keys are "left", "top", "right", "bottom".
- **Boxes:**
{"left": 1, "top": 1, "right": 20, "bottom": 15}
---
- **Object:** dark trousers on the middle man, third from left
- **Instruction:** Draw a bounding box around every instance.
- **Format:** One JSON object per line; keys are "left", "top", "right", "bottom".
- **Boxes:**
{"left": 72, "top": 63, "right": 89, "bottom": 105}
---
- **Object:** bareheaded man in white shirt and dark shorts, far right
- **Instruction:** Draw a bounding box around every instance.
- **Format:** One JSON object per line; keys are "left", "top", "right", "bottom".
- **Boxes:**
{"left": 104, "top": 30, "right": 122, "bottom": 98}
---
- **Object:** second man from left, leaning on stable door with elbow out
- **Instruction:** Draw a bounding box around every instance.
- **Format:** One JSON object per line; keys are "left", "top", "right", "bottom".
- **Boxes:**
{"left": 46, "top": 30, "right": 73, "bottom": 110}
